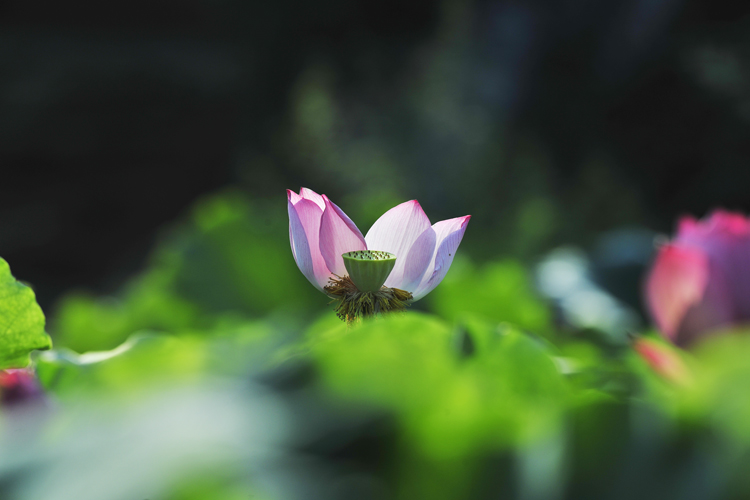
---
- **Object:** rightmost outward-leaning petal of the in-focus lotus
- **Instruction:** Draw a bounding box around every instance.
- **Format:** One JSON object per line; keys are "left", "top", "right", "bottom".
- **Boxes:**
{"left": 412, "top": 215, "right": 471, "bottom": 300}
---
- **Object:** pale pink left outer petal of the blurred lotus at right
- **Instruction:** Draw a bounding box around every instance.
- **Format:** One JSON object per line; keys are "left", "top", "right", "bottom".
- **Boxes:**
{"left": 646, "top": 244, "right": 709, "bottom": 340}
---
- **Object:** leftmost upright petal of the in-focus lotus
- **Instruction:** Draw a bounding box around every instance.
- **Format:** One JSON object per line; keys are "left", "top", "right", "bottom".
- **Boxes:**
{"left": 287, "top": 191, "right": 331, "bottom": 291}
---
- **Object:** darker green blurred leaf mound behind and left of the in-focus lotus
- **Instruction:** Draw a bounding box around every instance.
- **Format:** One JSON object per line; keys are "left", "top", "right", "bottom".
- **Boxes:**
{"left": 52, "top": 192, "right": 326, "bottom": 352}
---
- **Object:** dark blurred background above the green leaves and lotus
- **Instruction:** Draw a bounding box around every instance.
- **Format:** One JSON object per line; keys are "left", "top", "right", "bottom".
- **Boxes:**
{"left": 0, "top": 0, "right": 750, "bottom": 306}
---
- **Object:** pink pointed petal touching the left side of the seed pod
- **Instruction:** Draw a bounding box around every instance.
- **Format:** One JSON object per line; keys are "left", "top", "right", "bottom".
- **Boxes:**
{"left": 320, "top": 195, "right": 367, "bottom": 276}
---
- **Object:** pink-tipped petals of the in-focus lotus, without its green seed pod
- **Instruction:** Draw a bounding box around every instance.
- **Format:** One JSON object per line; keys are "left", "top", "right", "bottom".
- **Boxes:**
{"left": 287, "top": 188, "right": 471, "bottom": 300}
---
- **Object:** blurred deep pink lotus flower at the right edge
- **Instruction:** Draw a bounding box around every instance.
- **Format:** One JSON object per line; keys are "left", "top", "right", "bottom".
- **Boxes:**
{"left": 646, "top": 210, "right": 750, "bottom": 346}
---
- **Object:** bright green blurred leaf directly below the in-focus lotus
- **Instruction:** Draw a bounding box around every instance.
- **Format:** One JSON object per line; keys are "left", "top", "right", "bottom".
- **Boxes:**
{"left": 311, "top": 313, "right": 565, "bottom": 499}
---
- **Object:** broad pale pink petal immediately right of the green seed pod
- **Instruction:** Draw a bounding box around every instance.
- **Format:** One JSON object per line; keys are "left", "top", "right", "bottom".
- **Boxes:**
{"left": 365, "top": 200, "right": 435, "bottom": 290}
